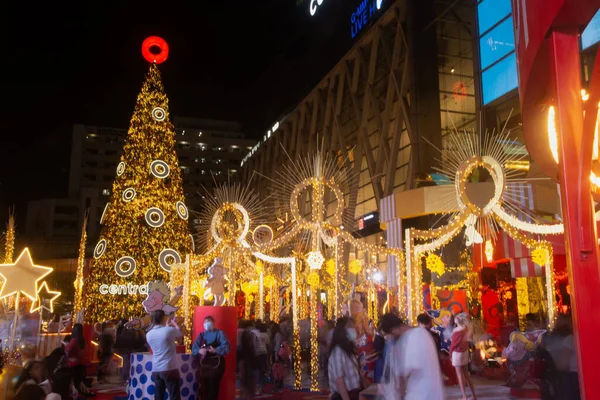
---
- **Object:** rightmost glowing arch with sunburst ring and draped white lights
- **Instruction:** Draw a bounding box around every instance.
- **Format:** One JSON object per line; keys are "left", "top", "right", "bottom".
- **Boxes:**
{"left": 405, "top": 122, "right": 564, "bottom": 328}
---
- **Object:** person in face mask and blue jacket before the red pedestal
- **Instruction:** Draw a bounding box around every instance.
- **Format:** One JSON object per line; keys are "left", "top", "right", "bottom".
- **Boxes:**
{"left": 192, "top": 315, "right": 230, "bottom": 400}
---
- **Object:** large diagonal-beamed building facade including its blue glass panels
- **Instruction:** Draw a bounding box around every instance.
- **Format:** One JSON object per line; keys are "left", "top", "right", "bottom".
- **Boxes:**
{"left": 242, "top": 0, "right": 597, "bottom": 276}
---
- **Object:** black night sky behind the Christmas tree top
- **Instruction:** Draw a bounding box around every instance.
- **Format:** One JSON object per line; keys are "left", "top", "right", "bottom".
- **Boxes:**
{"left": 0, "top": 0, "right": 358, "bottom": 226}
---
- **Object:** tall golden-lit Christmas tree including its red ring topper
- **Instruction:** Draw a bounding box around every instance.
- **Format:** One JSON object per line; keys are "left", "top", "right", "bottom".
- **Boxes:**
{"left": 83, "top": 37, "right": 193, "bottom": 322}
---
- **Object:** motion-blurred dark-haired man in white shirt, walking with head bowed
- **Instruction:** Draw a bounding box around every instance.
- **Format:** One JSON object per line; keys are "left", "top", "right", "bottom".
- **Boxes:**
{"left": 382, "top": 314, "right": 444, "bottom": 400}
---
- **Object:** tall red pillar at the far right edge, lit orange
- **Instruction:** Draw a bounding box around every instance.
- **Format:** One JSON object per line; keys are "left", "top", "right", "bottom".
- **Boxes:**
{"left": 540, "top": 29, "right": 600, "bottom": 399}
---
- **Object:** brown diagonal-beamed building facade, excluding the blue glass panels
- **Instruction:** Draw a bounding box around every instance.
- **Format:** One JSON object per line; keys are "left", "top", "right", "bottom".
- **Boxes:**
{"left": 242, "top": 0, "right": 477, "bottom": 263}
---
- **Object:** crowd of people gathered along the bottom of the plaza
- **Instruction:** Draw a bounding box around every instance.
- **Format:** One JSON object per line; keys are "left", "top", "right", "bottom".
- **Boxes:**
{"left": 9, "top": 304, "right": 579, "bottom": 400}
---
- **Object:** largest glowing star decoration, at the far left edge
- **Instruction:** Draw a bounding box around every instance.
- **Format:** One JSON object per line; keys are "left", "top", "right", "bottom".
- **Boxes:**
{"left": 0, "top": 248, "right": 52, "bottom": 301}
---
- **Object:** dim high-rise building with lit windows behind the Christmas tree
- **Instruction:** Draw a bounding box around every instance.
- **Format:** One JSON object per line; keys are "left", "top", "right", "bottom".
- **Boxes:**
{"left": 25, "top": 117, "right": 256, "bottom": 252}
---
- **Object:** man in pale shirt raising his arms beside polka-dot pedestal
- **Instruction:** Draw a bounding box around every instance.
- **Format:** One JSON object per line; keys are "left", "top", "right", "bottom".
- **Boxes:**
{"left": 146, "top": 310, "right": 181, "bottom": 400}
